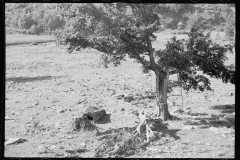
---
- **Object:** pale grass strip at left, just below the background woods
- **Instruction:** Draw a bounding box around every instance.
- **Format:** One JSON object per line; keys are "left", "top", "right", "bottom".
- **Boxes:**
{"left": 6, "top": 34, "right": 55, "bottom": 46}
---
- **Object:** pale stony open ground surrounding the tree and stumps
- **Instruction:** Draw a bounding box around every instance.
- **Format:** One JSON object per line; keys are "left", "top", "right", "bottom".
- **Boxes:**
{"left": 4, "top": 44, "right": 235, "bottom": 158}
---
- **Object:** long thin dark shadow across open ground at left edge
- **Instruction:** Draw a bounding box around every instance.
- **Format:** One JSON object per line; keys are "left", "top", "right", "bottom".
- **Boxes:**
{"left": 6, "top": 76, "right": 66, "bottom": 83}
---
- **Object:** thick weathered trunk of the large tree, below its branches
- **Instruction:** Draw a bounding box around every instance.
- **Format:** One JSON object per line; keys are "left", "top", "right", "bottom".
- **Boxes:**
{"left": 155, "top": 68, "right": 170, "bottom": 121}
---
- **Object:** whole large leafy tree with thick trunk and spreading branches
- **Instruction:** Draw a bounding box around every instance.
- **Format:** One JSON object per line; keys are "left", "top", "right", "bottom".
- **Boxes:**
{"left": 58, "top": 3, "right": 235, "bottom": 120}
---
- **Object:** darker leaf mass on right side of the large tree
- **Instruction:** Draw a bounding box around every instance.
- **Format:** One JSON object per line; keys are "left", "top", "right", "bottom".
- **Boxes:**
{"left": 157, "top": 27, "right": 235, "bottom": 91}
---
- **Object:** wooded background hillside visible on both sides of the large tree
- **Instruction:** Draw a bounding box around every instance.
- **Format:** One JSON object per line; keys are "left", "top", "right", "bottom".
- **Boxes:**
{"left": 5, "top": 3, "right": 235, "bottom": 38}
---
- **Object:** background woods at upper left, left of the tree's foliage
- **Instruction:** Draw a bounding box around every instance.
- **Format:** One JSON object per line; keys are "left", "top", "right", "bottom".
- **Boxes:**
{"left": 5, "top": 3, "right": 65, "bottom": 35}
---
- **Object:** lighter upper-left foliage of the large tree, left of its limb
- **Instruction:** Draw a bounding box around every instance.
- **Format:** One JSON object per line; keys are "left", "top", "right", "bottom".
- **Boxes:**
{"left": 57, "top": 3, "right": 159, "bottom": 65}
